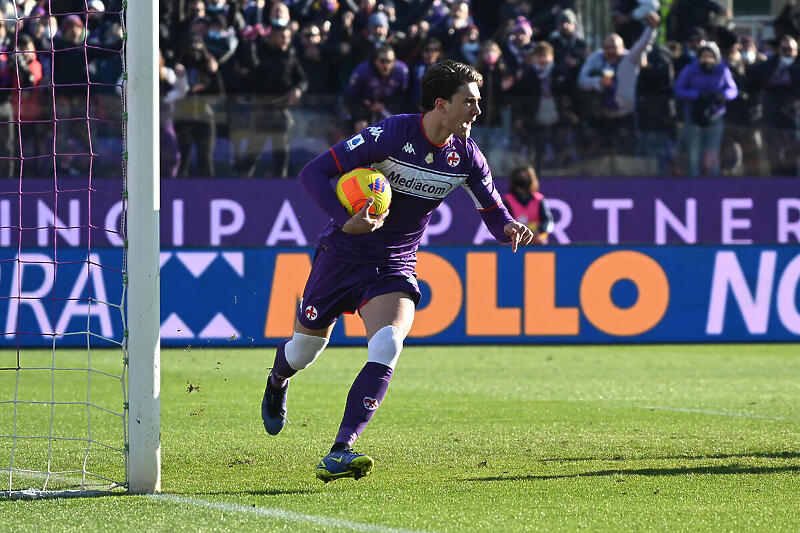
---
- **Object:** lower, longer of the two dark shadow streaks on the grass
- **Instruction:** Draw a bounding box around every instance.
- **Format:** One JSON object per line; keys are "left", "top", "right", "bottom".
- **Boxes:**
{"left": 465, "top": 465, "right": 800, "bottom": 481}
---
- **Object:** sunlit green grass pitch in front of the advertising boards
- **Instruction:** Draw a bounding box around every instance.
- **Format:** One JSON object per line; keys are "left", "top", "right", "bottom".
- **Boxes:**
{"left": 0, "top": 345, "right": 800, "bottom": 532}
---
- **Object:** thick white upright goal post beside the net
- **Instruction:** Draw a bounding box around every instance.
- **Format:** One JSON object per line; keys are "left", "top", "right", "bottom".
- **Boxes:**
{"left": 123, "top": 0, "right": 161, "bottom": 493}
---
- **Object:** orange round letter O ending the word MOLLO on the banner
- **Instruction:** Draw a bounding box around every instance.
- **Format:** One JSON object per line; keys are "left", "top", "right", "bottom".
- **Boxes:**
{"left": 581, "top": 251, "right": 669, "bottom": 336}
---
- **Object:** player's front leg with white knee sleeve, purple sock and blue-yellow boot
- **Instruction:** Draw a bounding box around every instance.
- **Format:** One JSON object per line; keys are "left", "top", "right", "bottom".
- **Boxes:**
{"left": 317, "top": 291, "right": 415, "bottom": 483}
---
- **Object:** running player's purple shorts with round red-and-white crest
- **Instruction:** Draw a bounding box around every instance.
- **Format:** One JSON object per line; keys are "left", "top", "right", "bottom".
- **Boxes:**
{"left": 297, "top": 248, "right": 421, "bottom": 329}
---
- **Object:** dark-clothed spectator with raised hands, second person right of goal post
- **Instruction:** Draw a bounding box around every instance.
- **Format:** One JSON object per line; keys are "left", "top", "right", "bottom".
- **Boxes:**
{"left": 175, "top": 36, "right": 224, "bottom": 178}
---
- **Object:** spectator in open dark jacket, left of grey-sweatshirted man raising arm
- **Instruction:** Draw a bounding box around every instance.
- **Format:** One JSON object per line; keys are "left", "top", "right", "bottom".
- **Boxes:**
{"left": 513, "top": 41, "right": 578, "bottom": 173}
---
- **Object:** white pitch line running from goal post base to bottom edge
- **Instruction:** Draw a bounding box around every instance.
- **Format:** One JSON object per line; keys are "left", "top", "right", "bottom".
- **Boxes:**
{"left": 148, "top": 493, "right": 438, "bottom": 533}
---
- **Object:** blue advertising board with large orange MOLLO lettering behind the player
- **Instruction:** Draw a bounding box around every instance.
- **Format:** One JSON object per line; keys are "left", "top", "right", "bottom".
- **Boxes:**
{"left": 0, "top": 246, "right": 800, "bottom": 346}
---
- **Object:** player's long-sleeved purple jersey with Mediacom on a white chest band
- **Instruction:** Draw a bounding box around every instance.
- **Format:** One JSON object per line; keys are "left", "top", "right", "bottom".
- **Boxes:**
{"left": 299, "top": 115, "right": 512, "bottom": 265}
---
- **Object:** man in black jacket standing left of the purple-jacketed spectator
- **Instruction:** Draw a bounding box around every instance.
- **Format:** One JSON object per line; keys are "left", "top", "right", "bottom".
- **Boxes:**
{"left": 236, "top": 25, "right": 308, "bottom": 178}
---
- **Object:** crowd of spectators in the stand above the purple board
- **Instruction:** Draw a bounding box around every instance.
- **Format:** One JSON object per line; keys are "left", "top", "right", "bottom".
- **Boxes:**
{"left": 0, "top": 0, "right": 800, "bottom": 177}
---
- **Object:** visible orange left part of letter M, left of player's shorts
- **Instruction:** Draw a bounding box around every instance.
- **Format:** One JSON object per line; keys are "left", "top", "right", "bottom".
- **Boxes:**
{"left": 264, "top": 253, "right": 311, "bottom": 337}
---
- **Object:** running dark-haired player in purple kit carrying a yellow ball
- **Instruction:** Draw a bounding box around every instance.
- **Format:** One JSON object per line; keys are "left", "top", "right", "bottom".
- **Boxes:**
{"left": 261, "top": 60, "right": 534, "bottom": 482}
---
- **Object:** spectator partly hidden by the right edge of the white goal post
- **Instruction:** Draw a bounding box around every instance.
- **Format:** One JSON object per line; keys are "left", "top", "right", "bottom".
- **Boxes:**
{"left": 158, "top": 53, "right": 189, "bottom": 179}
